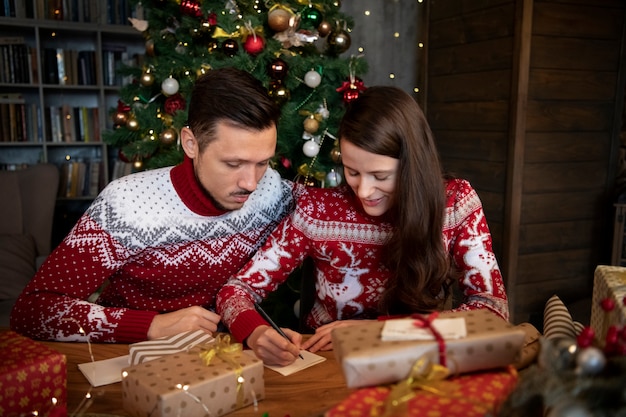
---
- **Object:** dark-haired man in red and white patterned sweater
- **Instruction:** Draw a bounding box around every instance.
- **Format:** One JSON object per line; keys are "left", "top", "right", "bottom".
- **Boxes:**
{"left": 11, "top": 68, "right": 294, "bottom": 343}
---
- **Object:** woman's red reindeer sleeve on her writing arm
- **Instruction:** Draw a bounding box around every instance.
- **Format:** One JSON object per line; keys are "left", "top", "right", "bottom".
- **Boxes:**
{"left": 216, "top": 204, "right": 311, "bottom": 341}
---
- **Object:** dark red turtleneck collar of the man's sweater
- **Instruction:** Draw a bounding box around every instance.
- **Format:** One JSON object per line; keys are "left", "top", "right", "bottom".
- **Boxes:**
{"left": 170, "top": 155, "right": 228, "bottom": 216}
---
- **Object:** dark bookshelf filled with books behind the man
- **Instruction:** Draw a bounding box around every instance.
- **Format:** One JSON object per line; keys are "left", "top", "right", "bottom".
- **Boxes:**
{"left": 0, "top": 0, "right": 145, "bottom": 244}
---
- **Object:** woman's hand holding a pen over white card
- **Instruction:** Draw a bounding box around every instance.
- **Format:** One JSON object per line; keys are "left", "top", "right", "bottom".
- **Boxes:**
{"left": 247, "top": 326, "right": 302, "bottom": 366}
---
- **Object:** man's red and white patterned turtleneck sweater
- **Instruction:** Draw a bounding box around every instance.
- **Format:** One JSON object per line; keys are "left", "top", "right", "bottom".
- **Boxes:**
{"left": 11, "top": 159, "right": 294, "bottom": 343}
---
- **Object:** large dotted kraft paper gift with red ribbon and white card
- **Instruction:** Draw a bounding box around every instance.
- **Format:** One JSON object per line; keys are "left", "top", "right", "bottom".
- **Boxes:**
{"left": 332, "top": 309, "right": 525, "bottom": 388}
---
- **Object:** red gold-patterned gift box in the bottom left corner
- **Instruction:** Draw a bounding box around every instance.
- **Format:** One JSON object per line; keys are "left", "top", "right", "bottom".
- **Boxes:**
{"left": 0, "top": 330, "right": 67, "bottom": 416}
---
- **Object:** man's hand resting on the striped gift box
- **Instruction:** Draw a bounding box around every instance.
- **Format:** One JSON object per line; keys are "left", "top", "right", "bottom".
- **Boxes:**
{"left": 148, "top": 306, "right": 221, "bottom": 340}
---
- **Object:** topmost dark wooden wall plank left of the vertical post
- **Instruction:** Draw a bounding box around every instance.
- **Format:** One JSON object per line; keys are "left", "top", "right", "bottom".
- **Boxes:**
{"left": 429, "top": 3, "right": 515, "bottom": 47}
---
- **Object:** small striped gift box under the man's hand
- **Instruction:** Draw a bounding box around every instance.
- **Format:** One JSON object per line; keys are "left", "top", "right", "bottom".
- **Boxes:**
{"left": 129, "top": 330, "right": 215, "bottom": 365}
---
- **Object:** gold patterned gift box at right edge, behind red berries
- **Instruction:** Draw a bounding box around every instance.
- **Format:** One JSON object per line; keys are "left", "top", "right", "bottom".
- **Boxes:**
{"left": 591, "top": 265, "right": 626, "bottom": 344}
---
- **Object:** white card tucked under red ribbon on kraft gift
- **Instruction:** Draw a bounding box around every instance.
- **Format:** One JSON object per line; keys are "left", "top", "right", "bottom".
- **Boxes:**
{"left": 381, "top": 317, "right": 467, "bottom": 342}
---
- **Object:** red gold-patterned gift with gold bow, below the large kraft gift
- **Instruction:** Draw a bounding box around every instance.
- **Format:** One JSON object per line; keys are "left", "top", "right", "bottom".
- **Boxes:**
{"left": 325, "top": 369, "right": 517, "bottom": 417}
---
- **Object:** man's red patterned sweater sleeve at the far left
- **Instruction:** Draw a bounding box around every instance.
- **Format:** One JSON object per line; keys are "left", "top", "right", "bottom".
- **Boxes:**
{"left": 11, "top": 198, "right": 157, "bottom": 343}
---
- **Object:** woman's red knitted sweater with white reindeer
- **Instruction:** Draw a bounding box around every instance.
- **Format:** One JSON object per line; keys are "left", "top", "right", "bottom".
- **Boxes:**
{"left": 217, "top": 179, "right": 509, "bottom": 340}
